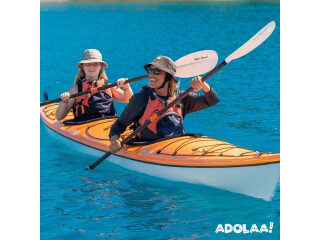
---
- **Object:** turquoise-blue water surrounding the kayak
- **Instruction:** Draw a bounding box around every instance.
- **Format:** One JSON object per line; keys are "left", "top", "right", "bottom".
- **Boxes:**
{"left": 39, "top": 3, "right": 280, "bottom": 240}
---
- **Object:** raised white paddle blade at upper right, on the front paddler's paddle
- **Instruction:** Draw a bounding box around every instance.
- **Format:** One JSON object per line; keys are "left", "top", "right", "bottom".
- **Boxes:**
{"left": 225, "top": 21, "right": 276, "bottom": 63}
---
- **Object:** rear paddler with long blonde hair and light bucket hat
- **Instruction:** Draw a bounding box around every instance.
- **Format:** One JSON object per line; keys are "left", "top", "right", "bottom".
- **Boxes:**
{"left": 56, "top": 49, "right": 133, "bottom": 121}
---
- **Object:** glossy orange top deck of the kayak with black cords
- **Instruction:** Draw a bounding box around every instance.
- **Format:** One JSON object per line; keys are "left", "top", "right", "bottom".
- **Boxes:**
{"left": 40, "top": 103, "right": 280, "bottom": 168}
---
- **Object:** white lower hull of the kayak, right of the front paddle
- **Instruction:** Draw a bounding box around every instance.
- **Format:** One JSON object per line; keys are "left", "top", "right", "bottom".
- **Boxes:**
{"left": 108, "top": 155, "right": 280, "bottom": 201}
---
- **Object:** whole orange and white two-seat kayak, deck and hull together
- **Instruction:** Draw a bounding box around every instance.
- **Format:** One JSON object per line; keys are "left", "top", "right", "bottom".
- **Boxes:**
{"left": 40, "top": 103, "right": 280, "bottom": 201}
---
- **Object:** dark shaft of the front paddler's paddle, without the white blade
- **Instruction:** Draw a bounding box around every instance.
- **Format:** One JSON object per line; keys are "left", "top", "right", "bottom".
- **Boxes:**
{"left": 86, "top": 61, "right": 227, "bottom": 170}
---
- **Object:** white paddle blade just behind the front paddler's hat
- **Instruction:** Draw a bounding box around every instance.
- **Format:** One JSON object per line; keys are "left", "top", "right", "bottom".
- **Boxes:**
{"left": 175, "top": 50, "right": 218, "bottom": 78}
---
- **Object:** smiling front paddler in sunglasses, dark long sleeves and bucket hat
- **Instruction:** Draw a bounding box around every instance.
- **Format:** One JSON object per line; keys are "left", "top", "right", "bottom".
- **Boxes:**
{"left": 109, "top": 56, "right": 219, "bottom": 153}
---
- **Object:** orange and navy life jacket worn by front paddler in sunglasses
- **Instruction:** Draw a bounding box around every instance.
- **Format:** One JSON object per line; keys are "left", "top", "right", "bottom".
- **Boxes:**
{"left": 138, "top": 89, "right": 184, "bottom": 138}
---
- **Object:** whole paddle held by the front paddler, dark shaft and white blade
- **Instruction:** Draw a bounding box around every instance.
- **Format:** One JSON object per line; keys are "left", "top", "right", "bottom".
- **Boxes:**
{"left": 85, "top": 21, "right": 275, "bottom": 170}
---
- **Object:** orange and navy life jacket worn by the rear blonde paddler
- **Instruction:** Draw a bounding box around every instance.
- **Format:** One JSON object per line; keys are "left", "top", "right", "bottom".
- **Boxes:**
{"left": 73, "top": 79, "right": 116, "bottom": 120}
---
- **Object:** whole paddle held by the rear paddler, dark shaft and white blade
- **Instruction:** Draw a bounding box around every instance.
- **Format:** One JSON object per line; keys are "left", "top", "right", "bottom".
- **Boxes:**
{"left": 40, "top": 50, "right": 218, "bottom": 107}
